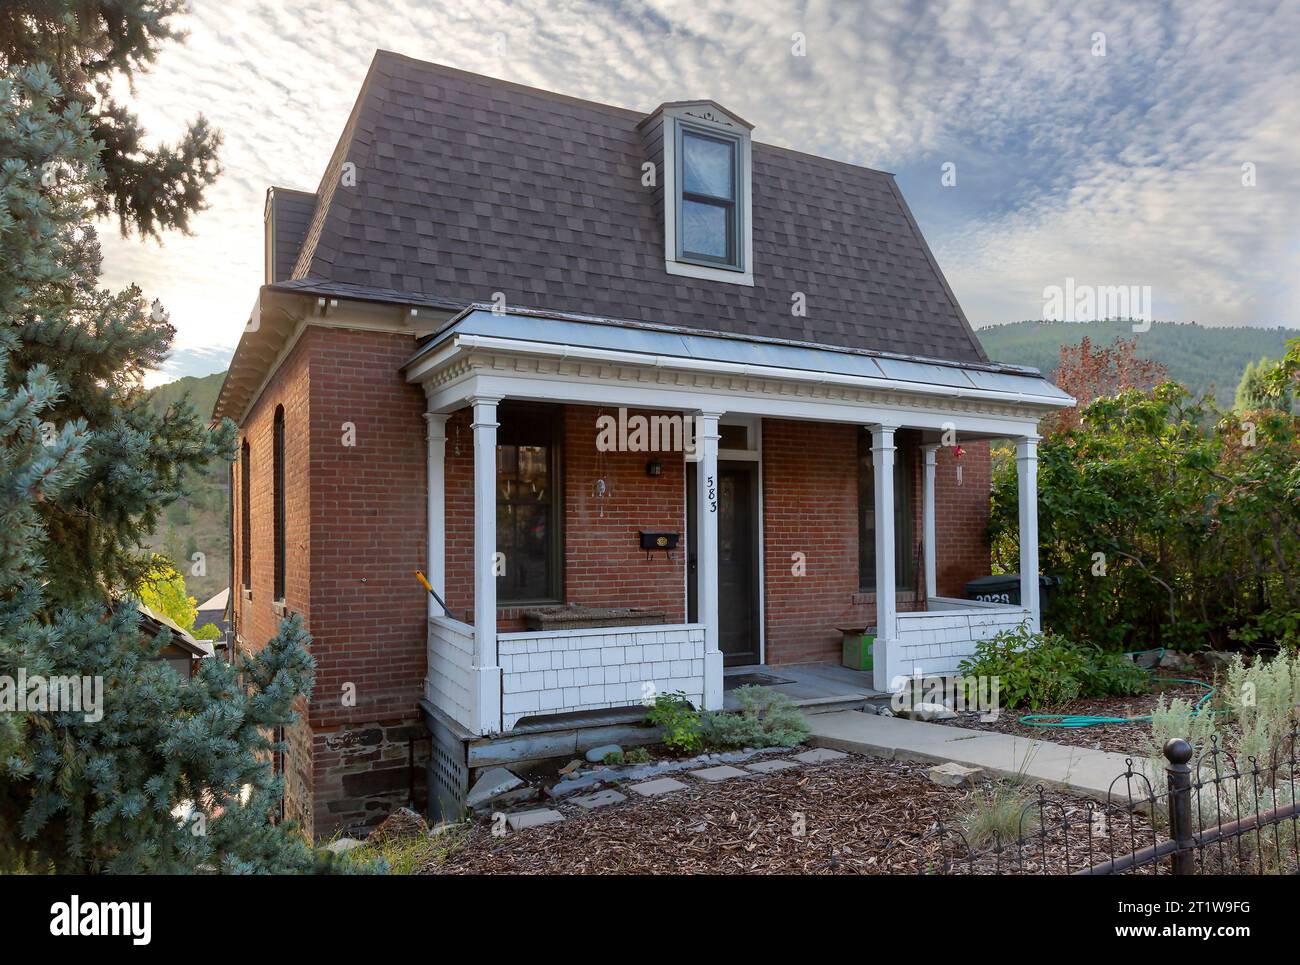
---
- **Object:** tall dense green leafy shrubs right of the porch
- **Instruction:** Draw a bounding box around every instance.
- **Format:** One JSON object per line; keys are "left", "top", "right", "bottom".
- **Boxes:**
{"left": 989, "top": 351, "right": 1300, "bottom": 650}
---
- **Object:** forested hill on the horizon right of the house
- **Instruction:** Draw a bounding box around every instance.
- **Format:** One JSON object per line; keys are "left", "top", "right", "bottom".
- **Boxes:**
{"left": 975, "top": 321, "right": 1300, "bottom": 408}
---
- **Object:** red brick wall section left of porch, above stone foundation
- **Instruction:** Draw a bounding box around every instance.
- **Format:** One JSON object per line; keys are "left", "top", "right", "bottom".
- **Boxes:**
{"left": 308, "top": 328, "right": 429, "bottom": 834}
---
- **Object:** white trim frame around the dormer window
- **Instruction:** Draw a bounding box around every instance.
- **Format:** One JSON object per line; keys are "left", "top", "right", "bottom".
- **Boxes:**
{"left": 663, "top": 108, "right": 754, "bottom": 287}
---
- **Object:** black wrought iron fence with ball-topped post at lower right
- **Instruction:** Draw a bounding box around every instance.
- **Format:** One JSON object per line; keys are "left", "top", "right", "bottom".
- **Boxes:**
{"left": 937, "top": 728, "right": 1300, "bottom": 874}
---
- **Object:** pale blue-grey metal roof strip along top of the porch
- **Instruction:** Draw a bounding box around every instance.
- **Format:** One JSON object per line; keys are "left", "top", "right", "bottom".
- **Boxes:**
{"left": 402, "top": 303, "right": 1074, "bottom": 407}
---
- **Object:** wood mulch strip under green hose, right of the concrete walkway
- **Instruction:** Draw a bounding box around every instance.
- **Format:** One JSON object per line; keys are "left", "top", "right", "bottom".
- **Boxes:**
{"left": 935, "top": 671, "right": 1214, "bottom": 758}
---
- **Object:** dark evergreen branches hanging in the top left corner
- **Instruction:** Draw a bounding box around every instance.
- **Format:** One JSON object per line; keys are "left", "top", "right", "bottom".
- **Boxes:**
{"left": 0, "top": 0, "right": 221, "bottom": 237}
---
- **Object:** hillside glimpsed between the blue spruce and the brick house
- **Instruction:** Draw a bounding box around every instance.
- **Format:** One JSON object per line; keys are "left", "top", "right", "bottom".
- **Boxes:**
{"left": 150, "top": 372, "right": 230, "bottom": 603}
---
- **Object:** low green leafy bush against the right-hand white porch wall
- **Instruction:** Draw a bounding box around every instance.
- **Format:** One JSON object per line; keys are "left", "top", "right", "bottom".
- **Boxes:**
{"left": 959, "top": 623, "right": 1147, "bottom": 710}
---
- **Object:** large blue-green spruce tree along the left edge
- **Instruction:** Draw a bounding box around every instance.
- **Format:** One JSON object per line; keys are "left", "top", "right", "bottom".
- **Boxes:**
{"left": 0, "top": 66, "right": 340, "bottom": 873}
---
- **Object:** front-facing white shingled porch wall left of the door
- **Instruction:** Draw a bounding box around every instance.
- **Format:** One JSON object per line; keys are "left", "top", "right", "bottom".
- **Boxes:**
{"left": 497, "top": 623, "right": 705, "bottom": 731}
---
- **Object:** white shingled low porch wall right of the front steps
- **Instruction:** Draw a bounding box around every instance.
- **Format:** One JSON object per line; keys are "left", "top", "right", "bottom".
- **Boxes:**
{"left": 889, "top": 597, "right": 1030, "bottom": 689}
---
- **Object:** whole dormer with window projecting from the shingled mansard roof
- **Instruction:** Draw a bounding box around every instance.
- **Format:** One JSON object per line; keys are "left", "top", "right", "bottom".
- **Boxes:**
{"left": 638, "top": 100, "right": 754, "bottom": 285}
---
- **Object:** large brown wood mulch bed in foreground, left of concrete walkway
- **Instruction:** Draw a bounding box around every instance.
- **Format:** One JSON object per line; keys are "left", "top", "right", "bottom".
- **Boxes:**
{"left": 420, "top": 754, "right": 1151, "bottom": 874}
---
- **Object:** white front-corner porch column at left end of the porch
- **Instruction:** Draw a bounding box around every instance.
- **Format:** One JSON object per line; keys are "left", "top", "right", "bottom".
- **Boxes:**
{"left": 471, "top": 397, "right": 501, "bottom": 734}
